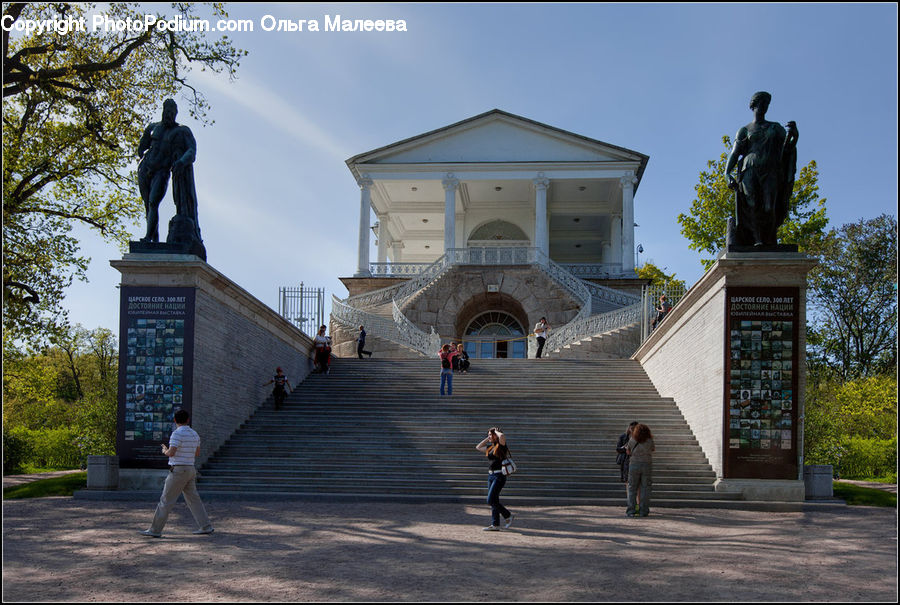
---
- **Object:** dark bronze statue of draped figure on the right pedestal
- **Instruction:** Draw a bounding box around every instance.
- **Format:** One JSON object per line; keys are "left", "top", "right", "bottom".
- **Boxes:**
{"left": 725, "top": 92, "right": 799, "bottom": 248}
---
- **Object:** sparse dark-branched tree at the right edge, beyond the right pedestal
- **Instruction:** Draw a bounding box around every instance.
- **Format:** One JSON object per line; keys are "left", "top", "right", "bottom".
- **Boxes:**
{"left": 809, "top": 214, "right": 897, "bottom": 381}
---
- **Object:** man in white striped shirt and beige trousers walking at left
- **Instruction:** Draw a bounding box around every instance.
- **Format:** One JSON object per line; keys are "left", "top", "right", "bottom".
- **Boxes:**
{"left": 140, "top": 410, "right": 213, "bottom": 538}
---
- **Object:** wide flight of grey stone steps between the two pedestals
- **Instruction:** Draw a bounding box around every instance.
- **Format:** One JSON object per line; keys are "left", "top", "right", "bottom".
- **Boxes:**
{"left": 199, "top": 359, "right": 740, "bottom": 507}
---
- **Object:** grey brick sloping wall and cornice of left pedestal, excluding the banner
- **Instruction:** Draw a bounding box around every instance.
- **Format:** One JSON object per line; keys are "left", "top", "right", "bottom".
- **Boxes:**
{"left": 110, "top": 254, "right": 312, "bottom": 465}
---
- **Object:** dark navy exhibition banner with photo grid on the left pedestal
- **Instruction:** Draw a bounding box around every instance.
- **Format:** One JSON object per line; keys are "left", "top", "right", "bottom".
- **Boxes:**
{"left": 117, "top": 286, "right": 194, "bottom": 468}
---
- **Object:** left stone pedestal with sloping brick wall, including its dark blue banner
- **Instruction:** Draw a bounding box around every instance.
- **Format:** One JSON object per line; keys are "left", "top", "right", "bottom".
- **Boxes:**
{"left": 110, "top": 254, "right": 312, "bottom": 478}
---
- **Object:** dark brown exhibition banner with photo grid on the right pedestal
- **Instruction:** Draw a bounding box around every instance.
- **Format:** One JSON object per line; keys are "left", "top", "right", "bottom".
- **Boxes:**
{"left": 724, "top": 287, "right": 804, "bottom": 479}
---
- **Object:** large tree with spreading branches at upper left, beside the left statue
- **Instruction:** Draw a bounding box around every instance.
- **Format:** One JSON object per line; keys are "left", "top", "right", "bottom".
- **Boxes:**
{"left": 3, "top": 3, "right": 246, "bottom": 339}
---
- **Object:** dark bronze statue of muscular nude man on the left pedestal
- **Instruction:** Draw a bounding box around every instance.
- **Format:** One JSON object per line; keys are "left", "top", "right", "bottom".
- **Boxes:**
{"left": 137, "top": 99, "right": 206, "bottom": 260}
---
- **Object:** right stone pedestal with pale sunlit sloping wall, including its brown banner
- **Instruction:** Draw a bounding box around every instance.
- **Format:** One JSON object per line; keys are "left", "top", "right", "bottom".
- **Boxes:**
{"left": 633, "top": 251, "right": 816, "bottom": 501}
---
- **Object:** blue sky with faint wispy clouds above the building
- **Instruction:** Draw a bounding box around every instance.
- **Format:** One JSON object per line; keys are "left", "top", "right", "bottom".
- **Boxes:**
{"left": 59, "top": 3, "right": 898, "bottom": 331}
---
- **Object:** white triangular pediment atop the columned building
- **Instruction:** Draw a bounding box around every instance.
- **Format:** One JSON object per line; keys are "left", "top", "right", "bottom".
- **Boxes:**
{"left": 347, "top": 109, "right": 647, "bottom": 166}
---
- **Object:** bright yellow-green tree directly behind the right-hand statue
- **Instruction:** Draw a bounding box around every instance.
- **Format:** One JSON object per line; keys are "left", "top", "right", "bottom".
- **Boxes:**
{"left": 678, "top": 136, "right": 828, "bottom": 269}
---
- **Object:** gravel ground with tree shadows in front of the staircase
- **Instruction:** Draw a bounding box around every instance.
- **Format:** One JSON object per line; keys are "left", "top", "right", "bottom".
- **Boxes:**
{"left": 3, "top": 498, "right": 897, "bottom": 602}
